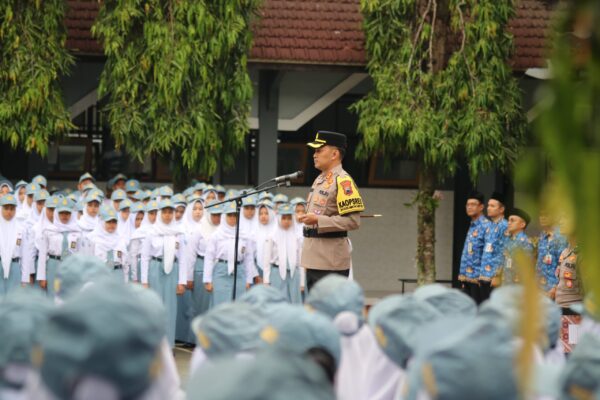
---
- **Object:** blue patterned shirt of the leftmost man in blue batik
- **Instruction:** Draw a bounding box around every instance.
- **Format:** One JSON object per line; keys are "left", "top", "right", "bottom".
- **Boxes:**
{"left": 458, "top": 215, "right": 490, "bottom": 283}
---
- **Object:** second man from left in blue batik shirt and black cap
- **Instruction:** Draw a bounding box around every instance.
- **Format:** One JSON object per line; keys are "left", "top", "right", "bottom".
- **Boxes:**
{"left": 479, "top": 192, "right": 507, "bottom": 302}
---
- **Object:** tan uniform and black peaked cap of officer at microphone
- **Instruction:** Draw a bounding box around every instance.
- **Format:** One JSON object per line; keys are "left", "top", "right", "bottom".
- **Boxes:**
{"left": 300, "top": 132, "right": 364, "bottom": 284}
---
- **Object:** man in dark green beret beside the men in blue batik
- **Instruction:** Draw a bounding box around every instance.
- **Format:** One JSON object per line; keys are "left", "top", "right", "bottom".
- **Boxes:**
{"left": 492, "top": 208, "right": 533, "bottom": 287}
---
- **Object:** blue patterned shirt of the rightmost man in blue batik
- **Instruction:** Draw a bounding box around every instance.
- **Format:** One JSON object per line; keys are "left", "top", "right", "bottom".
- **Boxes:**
{"left": 535, "top": 229, "right": 567, "bottom": 292}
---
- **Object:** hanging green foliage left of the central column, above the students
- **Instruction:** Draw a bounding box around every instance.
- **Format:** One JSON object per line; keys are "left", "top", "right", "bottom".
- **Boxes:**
{"left": 92, "top": 0, "right": 259, "bottom": 175}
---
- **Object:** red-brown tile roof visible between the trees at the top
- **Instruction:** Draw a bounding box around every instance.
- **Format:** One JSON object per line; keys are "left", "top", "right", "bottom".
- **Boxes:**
{"left": 67, "top": 0, "right": 553, "bottom": 71}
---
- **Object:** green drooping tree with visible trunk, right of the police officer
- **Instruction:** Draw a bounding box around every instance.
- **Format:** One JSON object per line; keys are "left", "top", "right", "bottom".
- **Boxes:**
{"left": 354, "top": 0, "right": 525, "bottom": 284}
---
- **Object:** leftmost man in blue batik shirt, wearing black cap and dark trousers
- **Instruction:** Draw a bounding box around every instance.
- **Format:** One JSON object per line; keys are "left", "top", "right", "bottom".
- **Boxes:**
{"left": 458, "top": 192, "right": 489, "bottom": 303}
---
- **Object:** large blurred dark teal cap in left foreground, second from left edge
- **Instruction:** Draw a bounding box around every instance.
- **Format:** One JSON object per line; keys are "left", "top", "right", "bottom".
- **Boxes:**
{"left": 39, "top": 281, "right": 166, "bottom": 399}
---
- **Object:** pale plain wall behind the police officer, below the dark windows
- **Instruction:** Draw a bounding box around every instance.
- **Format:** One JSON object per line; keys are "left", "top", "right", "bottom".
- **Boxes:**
{"left": 280, "top": 187, "right": 454, "bottom": 297}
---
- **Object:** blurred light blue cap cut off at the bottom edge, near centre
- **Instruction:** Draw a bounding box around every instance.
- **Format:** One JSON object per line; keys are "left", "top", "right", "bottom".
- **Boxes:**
{"left": 187, "top": 352, "right": 335, "bottom": 400}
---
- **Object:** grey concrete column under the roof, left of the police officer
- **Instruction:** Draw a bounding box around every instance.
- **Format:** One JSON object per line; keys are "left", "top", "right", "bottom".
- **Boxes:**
{"left": 257, "top": 70, "right": 283, "bottom": 184}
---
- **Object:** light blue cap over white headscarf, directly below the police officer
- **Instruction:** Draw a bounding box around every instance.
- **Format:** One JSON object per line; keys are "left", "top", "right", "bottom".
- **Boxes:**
{"left": 308, "top": 274, "right": 365, "bottom": 335}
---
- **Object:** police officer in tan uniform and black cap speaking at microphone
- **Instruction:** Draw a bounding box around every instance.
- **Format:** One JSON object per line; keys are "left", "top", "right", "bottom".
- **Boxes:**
{"left": 299, "top": 131, "right": 365, "bottom": 290}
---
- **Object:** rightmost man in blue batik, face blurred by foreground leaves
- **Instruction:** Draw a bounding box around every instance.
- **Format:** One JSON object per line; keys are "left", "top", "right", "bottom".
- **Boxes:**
{"left": 535, "top": 211, "right": 567, "bottom": 299}
